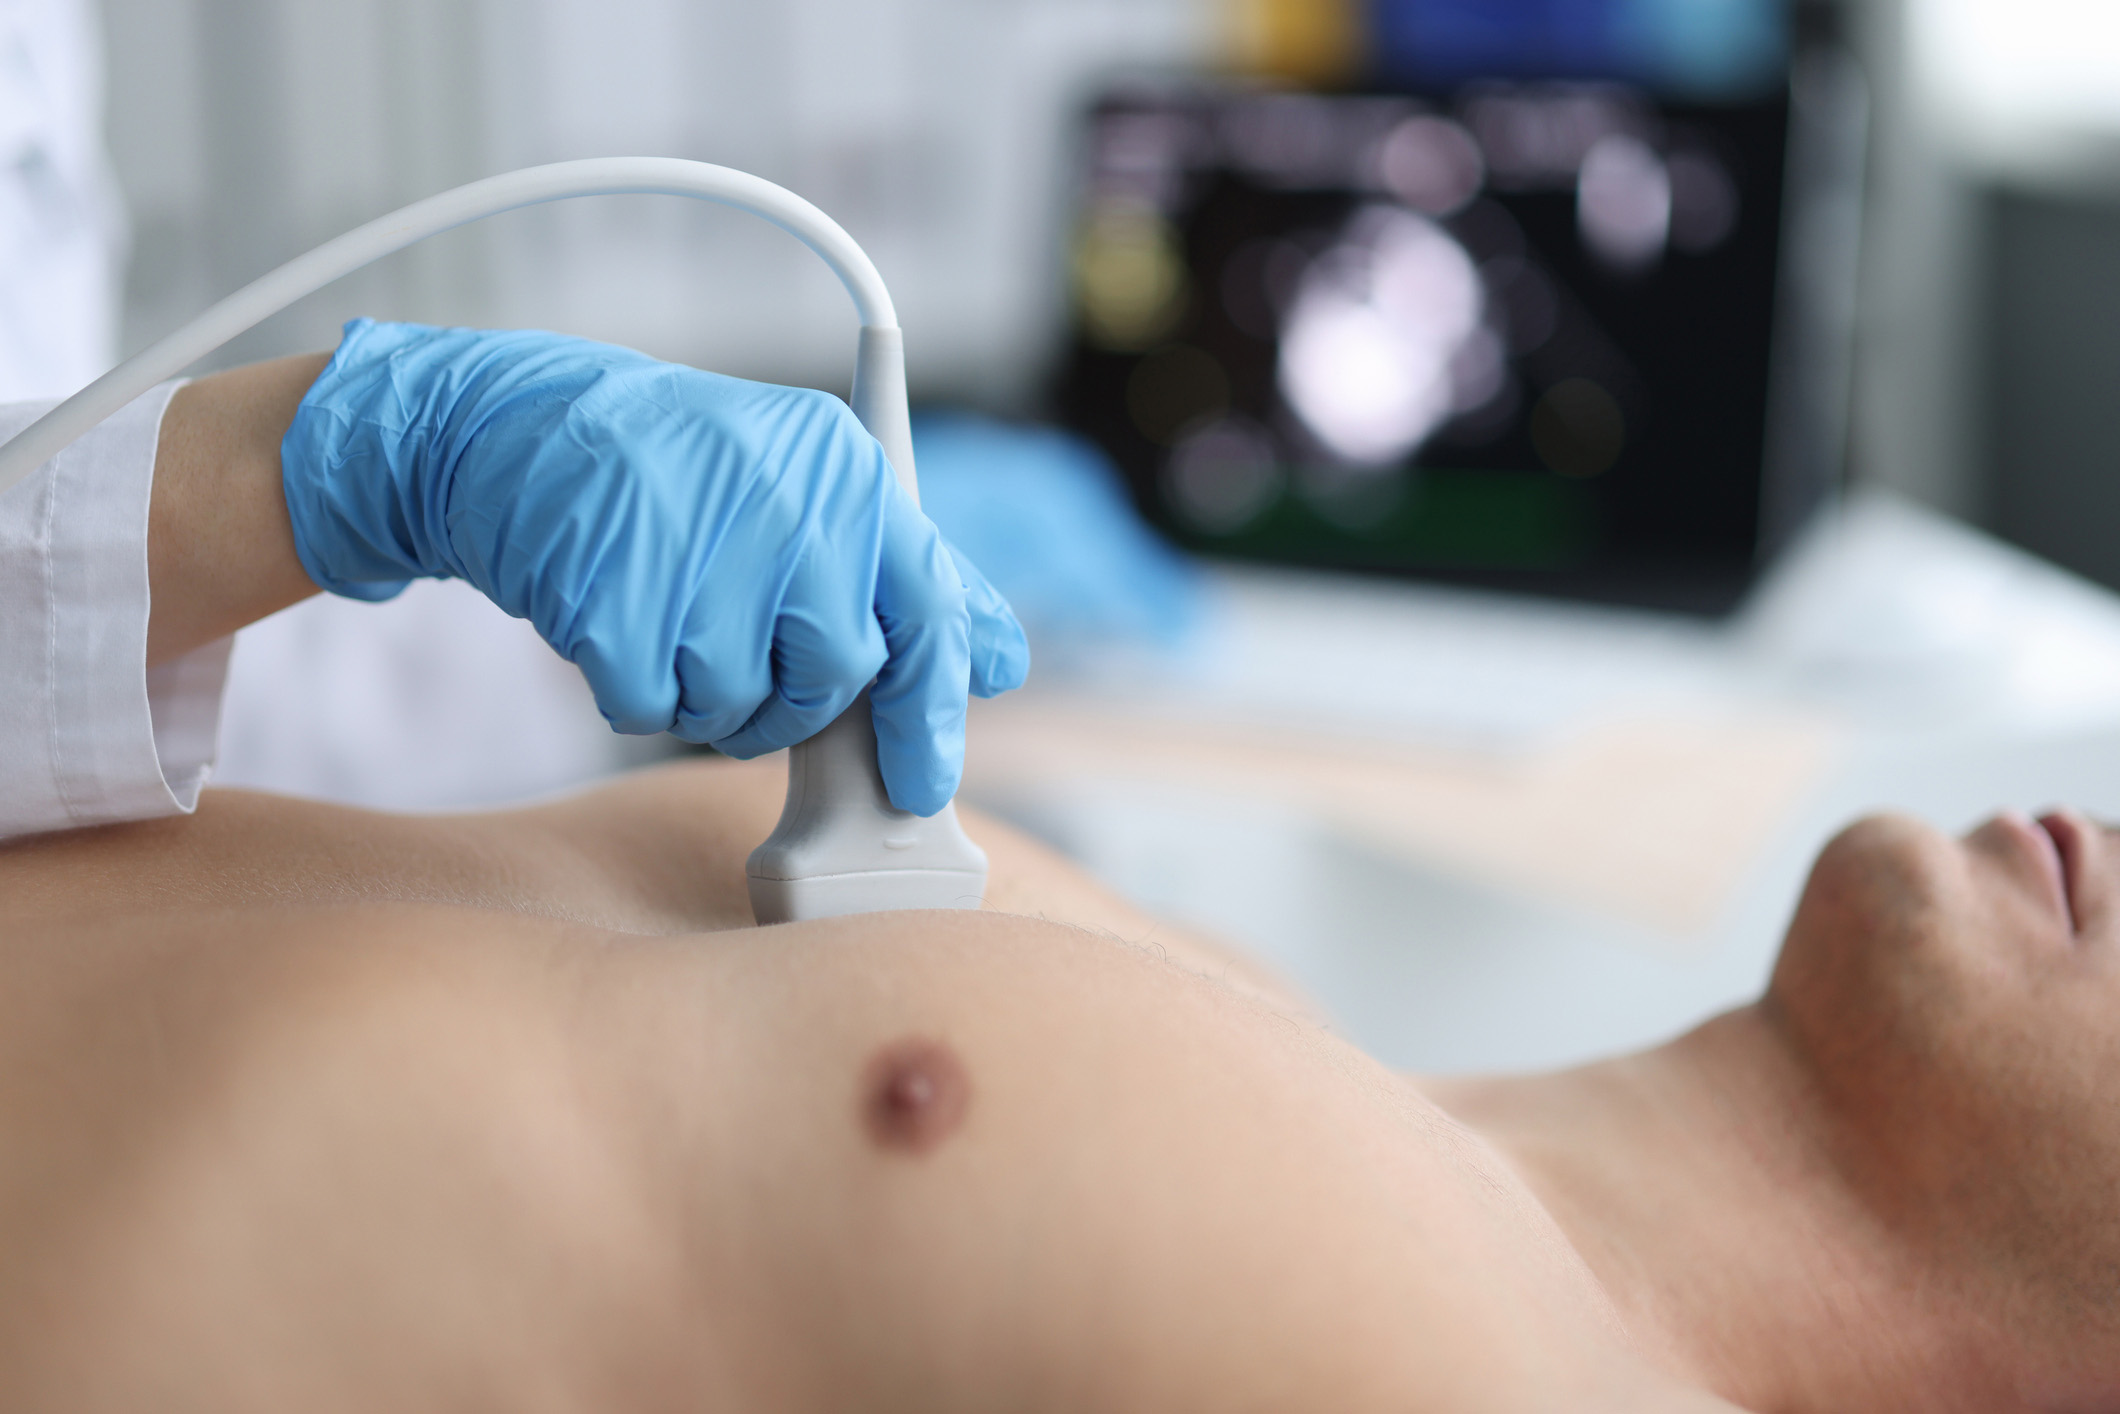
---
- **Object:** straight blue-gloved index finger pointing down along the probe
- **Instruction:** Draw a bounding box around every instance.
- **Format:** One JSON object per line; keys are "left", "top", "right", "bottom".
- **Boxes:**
{"left": 869, "top": 488, "right": 971, "bottom": 816}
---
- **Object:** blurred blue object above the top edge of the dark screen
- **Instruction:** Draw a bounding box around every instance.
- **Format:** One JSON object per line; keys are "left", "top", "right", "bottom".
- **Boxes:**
{"left": 1370, "top": 0, "right": 1787, "bottom": 98}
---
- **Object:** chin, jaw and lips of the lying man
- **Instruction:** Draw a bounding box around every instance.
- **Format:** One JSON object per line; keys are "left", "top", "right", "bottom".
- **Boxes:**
{"left": 1762, "top": 812, "right": 2120, "bottom": 1408}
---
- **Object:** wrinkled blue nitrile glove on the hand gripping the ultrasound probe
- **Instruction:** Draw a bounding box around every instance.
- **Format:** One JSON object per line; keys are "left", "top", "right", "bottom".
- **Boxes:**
{"left": 280, "top": 320, "right": 1030, "bottom": 814}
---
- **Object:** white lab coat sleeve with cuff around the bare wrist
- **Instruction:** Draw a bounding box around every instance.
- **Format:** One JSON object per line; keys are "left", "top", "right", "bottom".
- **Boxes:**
{"left": 0, "top": 384, "right": 229, "bottom": 835}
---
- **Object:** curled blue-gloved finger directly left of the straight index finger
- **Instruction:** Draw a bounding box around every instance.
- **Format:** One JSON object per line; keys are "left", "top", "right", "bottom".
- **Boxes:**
{"left": 714, "top": 547, "right": 888, "bottom": 759}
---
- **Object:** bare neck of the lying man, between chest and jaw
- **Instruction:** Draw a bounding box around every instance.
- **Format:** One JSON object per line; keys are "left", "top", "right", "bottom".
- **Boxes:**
{"left": 1429, "top": 1009, "right": 2012, "bottom": 1412}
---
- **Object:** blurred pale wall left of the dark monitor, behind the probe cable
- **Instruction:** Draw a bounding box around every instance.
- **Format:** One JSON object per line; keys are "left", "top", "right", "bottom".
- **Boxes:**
{"left": 102, "top": 0, "right": 1221, "bottom": 403}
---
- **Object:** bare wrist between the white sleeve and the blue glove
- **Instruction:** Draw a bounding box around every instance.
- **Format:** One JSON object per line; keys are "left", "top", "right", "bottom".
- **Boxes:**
{"left": 146, "top": 354, "right": 331, "bottom": 666}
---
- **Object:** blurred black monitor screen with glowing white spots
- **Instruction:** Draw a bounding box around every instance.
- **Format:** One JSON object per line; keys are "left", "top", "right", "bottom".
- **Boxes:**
{"left": 1060, "top": 72, "right": 1789, "bottom": 606}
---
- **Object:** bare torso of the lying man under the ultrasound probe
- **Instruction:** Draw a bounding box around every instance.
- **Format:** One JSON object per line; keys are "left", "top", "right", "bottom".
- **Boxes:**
{"left": 0, "top": 782, "right": 1721, "bottom": 1410}
